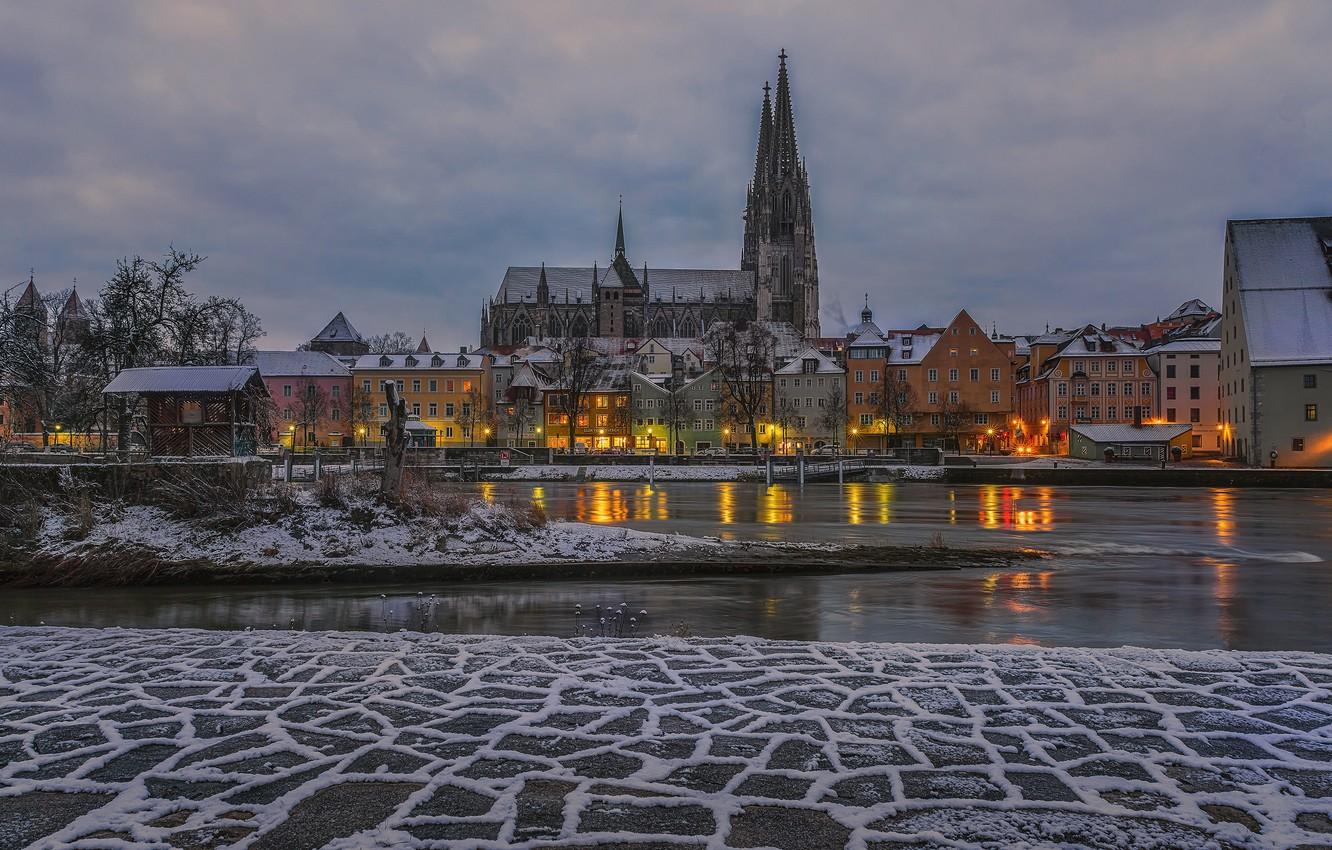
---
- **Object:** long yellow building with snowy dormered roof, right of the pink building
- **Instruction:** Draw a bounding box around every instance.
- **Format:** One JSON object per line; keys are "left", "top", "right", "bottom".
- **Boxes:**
{"left": 352, "top": 349, "right": 494, "bottom": 446}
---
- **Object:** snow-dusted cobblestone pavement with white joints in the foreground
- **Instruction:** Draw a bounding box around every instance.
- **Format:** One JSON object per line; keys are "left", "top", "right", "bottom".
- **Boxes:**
{"left": 0, "top": 629, "right": 1332, "bottom": 850}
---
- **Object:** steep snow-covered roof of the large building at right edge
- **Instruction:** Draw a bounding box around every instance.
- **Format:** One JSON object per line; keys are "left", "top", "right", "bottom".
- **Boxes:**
{"left": 1229, "top": 217, "right": 1332, "bottom": 366}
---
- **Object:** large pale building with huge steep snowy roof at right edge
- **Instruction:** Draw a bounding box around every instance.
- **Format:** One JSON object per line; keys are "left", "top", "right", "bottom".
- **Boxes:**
{"left": 1220, "top": 217, "right": 1332, "bottom": 466}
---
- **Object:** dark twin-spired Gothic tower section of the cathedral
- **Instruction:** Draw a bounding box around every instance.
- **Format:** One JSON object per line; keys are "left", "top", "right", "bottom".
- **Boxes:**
{"left": 741, "top": 51, "right": 821, "bottom": 337}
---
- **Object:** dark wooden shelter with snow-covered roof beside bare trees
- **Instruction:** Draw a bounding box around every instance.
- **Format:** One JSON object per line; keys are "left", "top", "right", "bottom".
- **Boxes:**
{"left": 103, "top": 366, "right": 268, "bottom": 457}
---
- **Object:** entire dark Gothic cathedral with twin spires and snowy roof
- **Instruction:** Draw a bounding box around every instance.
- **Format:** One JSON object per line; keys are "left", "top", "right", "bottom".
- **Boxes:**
{"left": 481, "top": 51, "right": 819, "bottom": 349}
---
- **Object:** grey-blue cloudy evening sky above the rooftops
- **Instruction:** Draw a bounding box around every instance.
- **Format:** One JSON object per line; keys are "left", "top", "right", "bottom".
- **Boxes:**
{"left": 0, "top": 0, "right": 1332, "bottom": 348}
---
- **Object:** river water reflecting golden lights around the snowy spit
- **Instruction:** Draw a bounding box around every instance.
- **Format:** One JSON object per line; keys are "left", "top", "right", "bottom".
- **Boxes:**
{"left": 0, "top": 482, "right": 1332, "bottom": 651}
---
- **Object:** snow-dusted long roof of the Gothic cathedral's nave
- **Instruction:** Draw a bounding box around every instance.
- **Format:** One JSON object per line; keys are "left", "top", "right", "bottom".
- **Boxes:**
{"left": 496, "top": 265, "right": 754, "bottom": 304}
